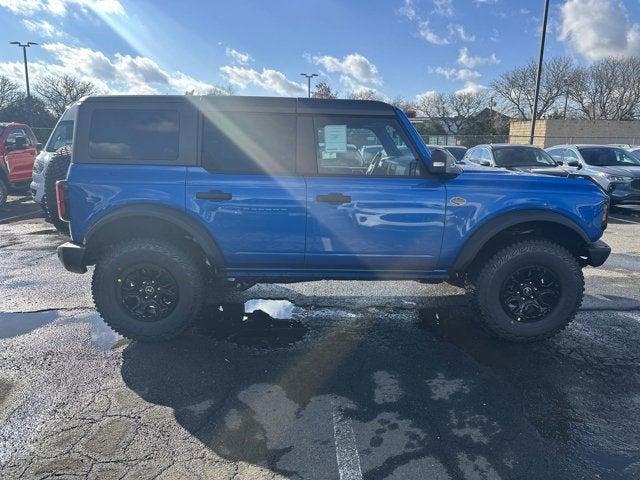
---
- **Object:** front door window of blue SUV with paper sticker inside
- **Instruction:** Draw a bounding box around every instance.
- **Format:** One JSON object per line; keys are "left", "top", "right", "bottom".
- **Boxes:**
{"left": 315, "top": 116, "right": 420, "bottom": 177}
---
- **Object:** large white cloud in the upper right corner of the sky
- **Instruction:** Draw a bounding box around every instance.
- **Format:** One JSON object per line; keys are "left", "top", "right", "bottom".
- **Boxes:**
{"left": 560, "top": 0, "right": 640, "bottom": 61}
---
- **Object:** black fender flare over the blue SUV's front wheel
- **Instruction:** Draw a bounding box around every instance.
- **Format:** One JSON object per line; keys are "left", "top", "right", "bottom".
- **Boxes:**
{"left": 452, "top": 210, "right": 591, "bottom": 272}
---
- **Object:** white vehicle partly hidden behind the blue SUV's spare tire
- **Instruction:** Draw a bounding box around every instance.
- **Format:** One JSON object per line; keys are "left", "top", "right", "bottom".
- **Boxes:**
{"left": 30, "top": 104, "right": 78, "bottom": 226}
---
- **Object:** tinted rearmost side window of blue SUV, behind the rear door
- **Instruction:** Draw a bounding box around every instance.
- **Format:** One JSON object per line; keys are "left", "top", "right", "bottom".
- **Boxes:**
{"left": 89, "top": 109, "right": 180, "bottom": 161}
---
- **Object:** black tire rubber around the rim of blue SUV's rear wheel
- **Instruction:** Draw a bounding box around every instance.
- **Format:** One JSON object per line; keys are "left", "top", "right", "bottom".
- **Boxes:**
{"left": 91, "top": 238, "right": 206, "bottom": 342}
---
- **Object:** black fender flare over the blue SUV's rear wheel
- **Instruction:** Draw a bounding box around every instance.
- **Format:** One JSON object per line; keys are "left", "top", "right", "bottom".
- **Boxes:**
{"left": 84, "top": 203, "right": 225, "bottom": 268}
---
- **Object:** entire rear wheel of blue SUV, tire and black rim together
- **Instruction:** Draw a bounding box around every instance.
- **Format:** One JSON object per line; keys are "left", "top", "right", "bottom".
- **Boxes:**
{"left": 91, "top": 239, "right": 206, "bottom": 342}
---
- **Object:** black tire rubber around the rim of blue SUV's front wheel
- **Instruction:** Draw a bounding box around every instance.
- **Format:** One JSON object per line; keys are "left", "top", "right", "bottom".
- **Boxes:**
{"left": 466, "top": 240, "right": 584, "bottom": 343}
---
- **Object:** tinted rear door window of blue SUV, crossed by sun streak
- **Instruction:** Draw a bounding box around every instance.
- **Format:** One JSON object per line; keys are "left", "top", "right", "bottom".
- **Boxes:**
{"left": 202, "top": 112, "right": 296, "bottom": 175}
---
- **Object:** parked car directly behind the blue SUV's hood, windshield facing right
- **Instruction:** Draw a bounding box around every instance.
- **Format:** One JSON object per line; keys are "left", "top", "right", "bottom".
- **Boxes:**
{"left": 463, "top": 143, "right": 569, "bottom": 177}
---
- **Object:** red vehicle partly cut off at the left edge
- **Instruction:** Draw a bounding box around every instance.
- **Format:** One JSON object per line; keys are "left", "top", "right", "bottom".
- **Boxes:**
{"left": 0, "top": 123, "right": 38, "bottom": 206}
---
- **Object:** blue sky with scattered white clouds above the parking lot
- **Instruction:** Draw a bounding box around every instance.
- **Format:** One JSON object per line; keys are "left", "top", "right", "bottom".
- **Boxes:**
{"left": 0, "top": 0, "right": 640, "bottom": 99}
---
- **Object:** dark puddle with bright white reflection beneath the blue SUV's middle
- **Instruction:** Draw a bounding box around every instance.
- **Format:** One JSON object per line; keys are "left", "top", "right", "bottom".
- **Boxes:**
{"left": 196, "top": 299, "right": 308, "bottom": 348}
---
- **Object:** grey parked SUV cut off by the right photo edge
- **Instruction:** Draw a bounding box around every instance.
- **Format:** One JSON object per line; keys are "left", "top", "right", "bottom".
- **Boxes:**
{"left": 547, "top": 145, "right": 640, "bottom": 205}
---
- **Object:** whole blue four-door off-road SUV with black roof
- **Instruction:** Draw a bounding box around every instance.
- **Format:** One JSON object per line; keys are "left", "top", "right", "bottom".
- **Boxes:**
{"left": 57, "top": 96, "right": 610, "bottom": 342}
